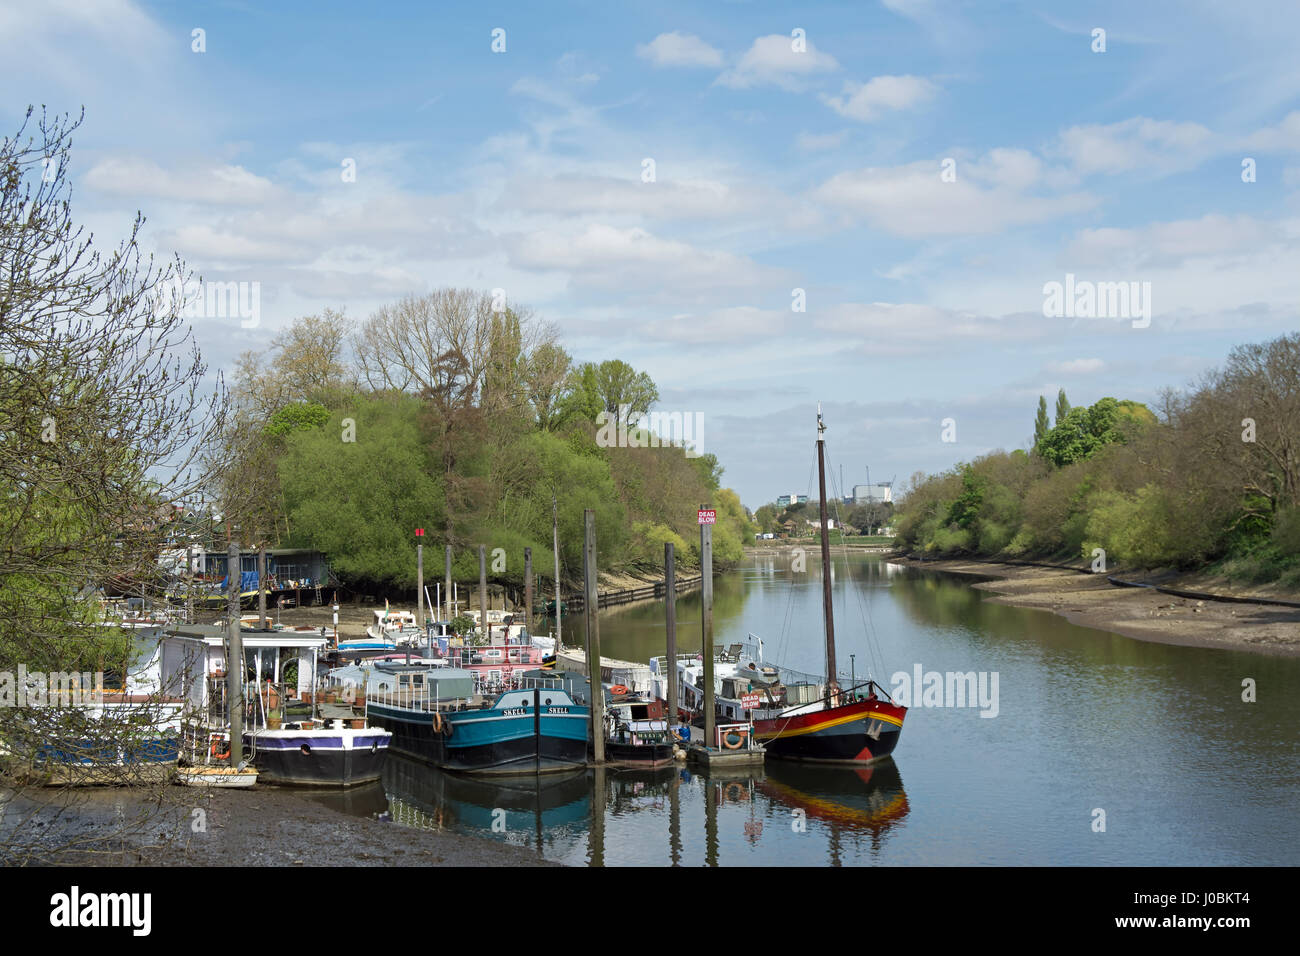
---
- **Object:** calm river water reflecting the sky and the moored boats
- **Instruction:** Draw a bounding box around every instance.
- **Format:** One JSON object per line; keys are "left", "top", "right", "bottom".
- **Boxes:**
{"left": 306, "top": 554, "right": 1300, "bottom": 866}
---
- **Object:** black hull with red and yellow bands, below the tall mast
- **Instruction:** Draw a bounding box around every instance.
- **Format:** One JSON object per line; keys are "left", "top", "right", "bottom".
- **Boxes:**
{"left": 754, "top": 700, "right": 907, "bottom": 765}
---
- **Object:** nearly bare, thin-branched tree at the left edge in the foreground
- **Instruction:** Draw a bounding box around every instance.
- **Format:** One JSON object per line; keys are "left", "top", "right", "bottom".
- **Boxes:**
{"left": 0, "top": 109, "right": 226, "bottom": 864}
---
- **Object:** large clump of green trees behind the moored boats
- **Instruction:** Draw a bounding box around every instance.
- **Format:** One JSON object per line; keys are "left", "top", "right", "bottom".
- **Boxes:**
{"left": 216, "top": 289, "right": 751, "bottom": 589}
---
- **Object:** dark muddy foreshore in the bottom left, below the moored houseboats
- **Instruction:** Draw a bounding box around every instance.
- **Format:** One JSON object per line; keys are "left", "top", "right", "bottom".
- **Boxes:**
{"left": 0, "top": 784, "right": 555, "bottom": 866}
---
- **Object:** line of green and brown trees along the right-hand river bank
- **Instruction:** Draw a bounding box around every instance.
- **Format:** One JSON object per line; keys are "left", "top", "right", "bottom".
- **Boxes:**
{"left": 896, "top": 333, "right": 1300, "bottom": 587}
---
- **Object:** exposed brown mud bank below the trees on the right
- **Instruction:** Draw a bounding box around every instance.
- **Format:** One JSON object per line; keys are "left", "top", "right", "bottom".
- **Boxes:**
{"left": 889, "top": 555, "right": 1300, "bottom": 657}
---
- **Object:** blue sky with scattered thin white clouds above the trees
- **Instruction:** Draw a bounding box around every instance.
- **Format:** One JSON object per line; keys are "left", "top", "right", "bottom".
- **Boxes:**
{"left": 0, "top": 0, "right": 1300, "bottom": 509}
